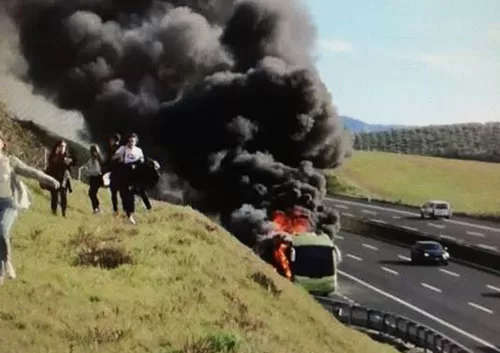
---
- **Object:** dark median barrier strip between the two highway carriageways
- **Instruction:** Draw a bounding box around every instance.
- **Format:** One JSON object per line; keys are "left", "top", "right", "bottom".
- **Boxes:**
{"left": 340, "top": 214, "right": 500, "bottom": 271}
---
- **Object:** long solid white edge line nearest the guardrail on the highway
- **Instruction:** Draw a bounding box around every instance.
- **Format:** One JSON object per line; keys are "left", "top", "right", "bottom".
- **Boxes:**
{"left": 338, "top": 270, "right": 500, "bottom": 353}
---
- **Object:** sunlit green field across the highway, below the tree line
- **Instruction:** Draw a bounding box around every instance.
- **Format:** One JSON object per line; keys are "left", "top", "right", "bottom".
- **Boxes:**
{"left": 327, "top": 151, "right": 500, "bottom": 216}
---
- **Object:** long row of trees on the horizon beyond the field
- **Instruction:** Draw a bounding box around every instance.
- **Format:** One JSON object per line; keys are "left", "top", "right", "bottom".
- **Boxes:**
{"left": 354, "top": 122, "right": 500, "bottom": 162}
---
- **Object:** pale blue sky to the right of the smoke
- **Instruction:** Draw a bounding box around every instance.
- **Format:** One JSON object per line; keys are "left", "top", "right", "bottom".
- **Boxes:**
{"left": 304, "top": 0, "right": 500, "bottom": 125}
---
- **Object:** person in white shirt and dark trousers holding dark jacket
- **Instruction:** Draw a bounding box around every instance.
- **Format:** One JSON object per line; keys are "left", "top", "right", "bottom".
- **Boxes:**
{"left": 113, "top": 134, "right": 144, "bottom": 224}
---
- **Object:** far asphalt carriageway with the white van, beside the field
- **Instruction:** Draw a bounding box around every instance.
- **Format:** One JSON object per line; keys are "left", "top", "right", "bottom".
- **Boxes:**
{"left": 326, "top": 198, "right": 500, "bottom": 251}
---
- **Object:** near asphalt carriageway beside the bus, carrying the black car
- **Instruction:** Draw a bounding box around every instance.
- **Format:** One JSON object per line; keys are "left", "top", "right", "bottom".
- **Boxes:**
{"left": 337, "top": 232, "right": 500, "bottom": 353}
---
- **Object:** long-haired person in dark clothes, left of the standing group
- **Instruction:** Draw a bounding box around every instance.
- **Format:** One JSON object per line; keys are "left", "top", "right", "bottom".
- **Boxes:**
{"left": 46, "top": 140, "right": 76, "bottom": 217}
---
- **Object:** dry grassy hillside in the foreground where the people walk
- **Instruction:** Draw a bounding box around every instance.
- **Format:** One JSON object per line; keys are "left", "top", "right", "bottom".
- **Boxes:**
{"left": 0, "top": 102, "right": 396, "bottom": 353}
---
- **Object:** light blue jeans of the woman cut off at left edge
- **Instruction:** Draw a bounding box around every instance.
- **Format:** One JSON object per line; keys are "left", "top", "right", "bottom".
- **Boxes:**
{"left": 0, "top": 197, "right": 17, "bottom": 280}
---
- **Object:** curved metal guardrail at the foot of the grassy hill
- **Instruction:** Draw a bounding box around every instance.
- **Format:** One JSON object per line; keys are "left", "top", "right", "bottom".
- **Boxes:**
{"left": 314, "top": 296, "right": 472, "bottom": 353}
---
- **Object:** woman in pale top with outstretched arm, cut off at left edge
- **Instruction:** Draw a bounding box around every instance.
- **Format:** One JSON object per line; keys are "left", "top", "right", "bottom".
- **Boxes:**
{"left": 0, "top": 132, "right": 60, "bottom": 285}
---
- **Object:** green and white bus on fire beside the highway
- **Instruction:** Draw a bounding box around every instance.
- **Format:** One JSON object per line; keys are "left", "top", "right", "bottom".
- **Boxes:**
{"left": 258, "top": 207, "right": 341, "bottom": 295}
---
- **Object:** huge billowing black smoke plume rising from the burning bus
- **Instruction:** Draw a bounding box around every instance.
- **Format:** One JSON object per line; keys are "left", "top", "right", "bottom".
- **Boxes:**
{"left": 0, "top": 0, "right": 352, "bottom": 246}
